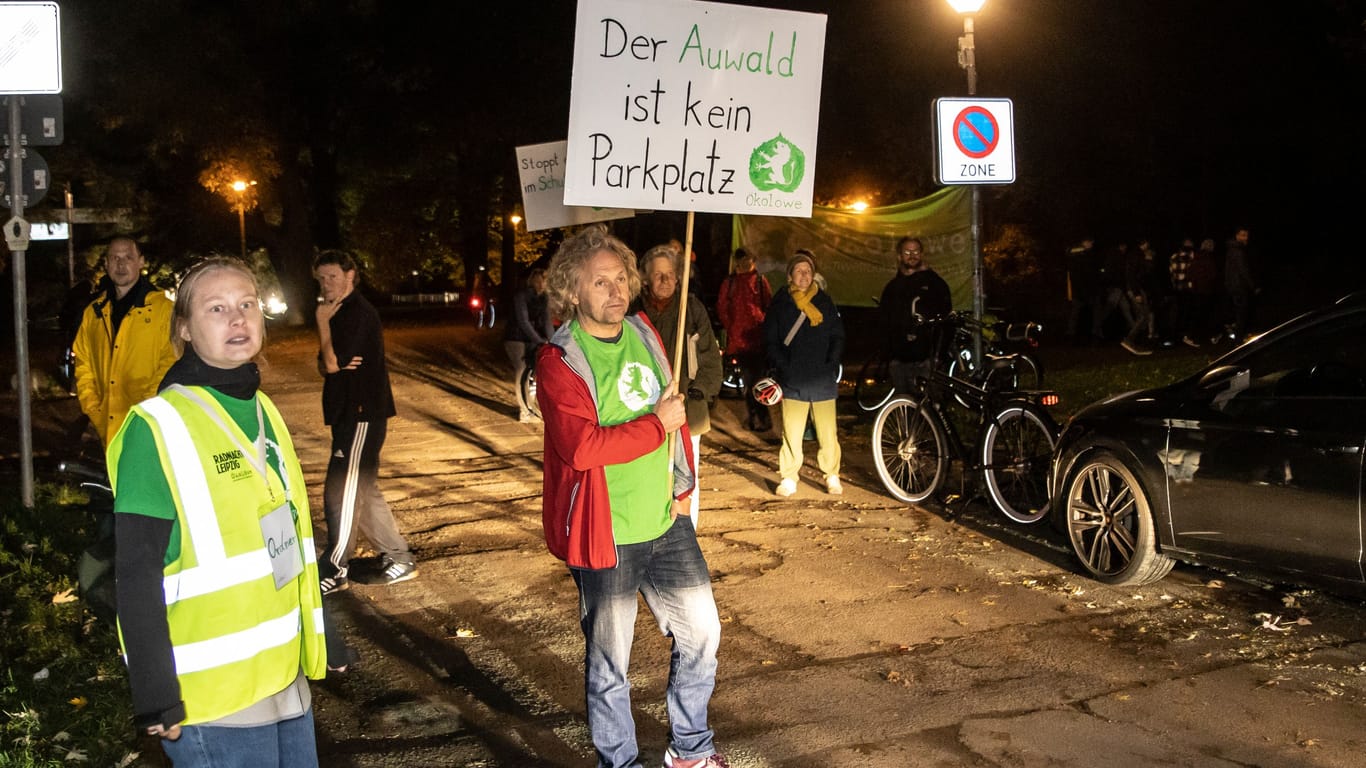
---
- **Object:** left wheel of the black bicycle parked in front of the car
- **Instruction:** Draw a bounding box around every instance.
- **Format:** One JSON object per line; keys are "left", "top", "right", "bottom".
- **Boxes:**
{"left": 873, "top": 398, "right": 948, "bottom": 504}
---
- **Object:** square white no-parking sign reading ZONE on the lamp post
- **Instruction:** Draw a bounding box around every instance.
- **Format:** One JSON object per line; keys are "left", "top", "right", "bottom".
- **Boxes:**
{"left": 934, "top": 98, "right": 1015, "bottom": 184}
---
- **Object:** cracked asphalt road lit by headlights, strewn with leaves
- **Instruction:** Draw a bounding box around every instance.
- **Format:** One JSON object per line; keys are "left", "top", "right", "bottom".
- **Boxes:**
{"left": 13, "top": 306, "right": 1366, "bottom": 768}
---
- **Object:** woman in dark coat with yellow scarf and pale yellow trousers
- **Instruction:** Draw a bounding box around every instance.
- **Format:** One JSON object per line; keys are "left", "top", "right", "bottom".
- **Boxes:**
{"left": 764, "top": 249, "right": 844, "bottom": 496}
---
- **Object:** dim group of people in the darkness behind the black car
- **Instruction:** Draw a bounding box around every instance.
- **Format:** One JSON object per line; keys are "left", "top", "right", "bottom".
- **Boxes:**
{"left": 1065, "top": 227, "right": 1261, "bottom": 355}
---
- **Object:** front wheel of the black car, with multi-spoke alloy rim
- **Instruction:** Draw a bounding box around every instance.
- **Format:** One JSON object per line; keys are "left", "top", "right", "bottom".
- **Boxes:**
{"left": 1067, "top": 454, "right": 1175, "bottom": 585}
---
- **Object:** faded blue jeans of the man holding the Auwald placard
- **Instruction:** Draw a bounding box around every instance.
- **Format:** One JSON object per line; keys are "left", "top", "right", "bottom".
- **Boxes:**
{"left": 571, "top": 518, "right": 721, "bottom": 768}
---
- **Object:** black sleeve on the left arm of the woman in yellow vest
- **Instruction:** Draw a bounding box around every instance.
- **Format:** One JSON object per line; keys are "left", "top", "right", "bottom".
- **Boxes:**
{"left": 115, "top": 514, "right": 184, "bottom": 730}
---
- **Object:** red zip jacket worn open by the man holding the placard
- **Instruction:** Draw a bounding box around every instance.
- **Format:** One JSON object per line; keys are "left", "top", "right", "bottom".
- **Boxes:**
{"left": 535, "top": 313, "right": 697, "bottom": 570}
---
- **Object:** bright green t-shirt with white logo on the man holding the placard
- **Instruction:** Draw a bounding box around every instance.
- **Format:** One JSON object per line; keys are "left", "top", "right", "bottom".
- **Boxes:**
{"left": 574, "top": 323, "right": 673, "bottom": 544}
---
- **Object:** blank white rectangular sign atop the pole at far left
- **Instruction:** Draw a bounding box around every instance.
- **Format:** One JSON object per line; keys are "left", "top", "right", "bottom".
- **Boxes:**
{"left": 0, "top": 3, "right": 61, "bottom": 93}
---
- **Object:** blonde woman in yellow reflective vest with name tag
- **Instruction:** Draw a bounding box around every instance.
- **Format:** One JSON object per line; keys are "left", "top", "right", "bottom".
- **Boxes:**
{"left": 108, "top": 258, "right": 326, "bottom": 768}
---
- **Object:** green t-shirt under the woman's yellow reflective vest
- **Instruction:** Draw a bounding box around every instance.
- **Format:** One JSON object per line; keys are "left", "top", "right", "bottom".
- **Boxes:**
{"left": 113, "top": 387, "right": 280, "bottom": 564}
